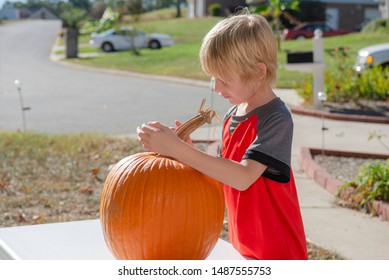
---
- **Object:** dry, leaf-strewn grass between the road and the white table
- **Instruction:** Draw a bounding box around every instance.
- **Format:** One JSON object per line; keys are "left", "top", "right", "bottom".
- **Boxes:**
{"left": 0, "top": 132, "right": 341, "bottom": 260}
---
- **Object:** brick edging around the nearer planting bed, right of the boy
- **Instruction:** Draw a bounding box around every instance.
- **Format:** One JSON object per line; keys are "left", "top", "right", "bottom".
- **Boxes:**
{"left": 299, "top": 147, "right": 389, "bottom": 221}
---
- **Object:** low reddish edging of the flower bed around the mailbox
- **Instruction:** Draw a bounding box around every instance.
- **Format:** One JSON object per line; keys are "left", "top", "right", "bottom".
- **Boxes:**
{"left": 291, "top": 107, "right": 389, "bottom": 124}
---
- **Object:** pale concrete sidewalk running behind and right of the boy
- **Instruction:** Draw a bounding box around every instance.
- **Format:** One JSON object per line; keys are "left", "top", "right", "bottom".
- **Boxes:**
{"left": 193, "top": 89, "right": 389, "bottom": 260}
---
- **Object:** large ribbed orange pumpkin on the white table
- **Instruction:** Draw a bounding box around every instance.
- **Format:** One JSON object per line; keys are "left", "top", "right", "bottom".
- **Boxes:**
{"left": 100, "top": 100, "right": 224, "bottom": 260}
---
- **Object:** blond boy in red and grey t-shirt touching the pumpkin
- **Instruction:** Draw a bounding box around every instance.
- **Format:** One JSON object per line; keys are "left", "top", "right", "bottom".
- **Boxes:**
{"left": 137, "top": 14, "right": 307, "bottom": 259}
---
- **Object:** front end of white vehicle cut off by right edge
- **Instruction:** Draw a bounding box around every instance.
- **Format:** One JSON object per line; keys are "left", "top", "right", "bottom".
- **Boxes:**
{"left": 353, "top": 43, "right": 389, "bottom": 73}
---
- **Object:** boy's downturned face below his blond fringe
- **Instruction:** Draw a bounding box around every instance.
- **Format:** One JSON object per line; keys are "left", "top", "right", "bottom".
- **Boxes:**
{"left": 211, "top": 77, "right": 257, "bottom": 105}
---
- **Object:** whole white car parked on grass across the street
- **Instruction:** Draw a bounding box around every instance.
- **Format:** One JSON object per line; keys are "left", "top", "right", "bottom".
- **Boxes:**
{"left": 89, "top": 26, "right": 174, "bottom": 52}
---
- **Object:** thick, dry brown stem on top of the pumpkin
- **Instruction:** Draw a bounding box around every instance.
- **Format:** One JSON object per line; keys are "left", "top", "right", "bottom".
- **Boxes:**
{"left": 175, "top": 99, "right": 219, "bottom": 141}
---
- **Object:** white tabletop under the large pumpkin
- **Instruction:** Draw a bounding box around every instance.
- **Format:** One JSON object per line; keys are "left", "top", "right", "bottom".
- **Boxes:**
{"left": 0, "top": 219, "right": 244, "bottom": 260}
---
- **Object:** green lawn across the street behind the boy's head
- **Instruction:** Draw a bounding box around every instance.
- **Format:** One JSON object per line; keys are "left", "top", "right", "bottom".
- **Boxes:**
{"left": 72, "top": 14, "right": 387, "bottom": 88}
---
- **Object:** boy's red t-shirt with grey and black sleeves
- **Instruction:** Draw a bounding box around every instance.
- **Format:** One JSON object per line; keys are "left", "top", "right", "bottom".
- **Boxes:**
{"left": 221, "top": 99, "right": 307, "bottom": 260}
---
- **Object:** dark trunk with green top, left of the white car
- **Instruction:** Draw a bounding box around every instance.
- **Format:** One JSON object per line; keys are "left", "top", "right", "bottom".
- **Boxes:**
{"left": 60, "top": 5, "right": 88, "bottom": 58}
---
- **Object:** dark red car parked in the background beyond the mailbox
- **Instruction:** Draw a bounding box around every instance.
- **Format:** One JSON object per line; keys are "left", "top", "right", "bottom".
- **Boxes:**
{"left": 283, "top": 22, "right": 352, "bottom": 40}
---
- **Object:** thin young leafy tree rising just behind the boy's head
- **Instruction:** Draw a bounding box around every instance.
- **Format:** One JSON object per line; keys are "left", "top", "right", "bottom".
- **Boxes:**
{"left": 255, "top": 0, "right": 300, "bottom": 50}
